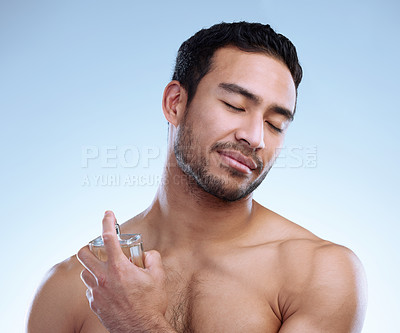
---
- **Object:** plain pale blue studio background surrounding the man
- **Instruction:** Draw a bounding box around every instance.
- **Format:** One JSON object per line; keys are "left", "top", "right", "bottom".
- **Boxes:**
{"left": 0, "top": 0, "right": 400, "bottom": 333}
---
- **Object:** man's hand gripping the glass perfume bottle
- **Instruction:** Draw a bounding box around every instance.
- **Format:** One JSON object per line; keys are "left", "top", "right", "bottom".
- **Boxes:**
{"left": 77, "top": 211, "right": 172, "bottom": 333}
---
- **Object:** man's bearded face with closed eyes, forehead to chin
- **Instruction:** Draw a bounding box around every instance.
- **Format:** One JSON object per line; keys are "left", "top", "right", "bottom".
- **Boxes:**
{"left": 174, "top": 47, "right": 296, "bottom": 201}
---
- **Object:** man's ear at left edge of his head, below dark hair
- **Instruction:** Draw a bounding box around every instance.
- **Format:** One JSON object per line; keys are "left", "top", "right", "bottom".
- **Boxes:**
{"left": 162, "top": 80, "right": 187, "bottom": 127}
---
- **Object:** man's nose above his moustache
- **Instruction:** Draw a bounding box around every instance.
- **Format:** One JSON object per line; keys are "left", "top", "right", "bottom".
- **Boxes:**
{"left": 235, "top": 115, "right": 265, "bottom": 149}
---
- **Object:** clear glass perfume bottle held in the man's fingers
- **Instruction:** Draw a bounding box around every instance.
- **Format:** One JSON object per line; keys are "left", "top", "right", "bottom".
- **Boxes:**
{"left": 89, "top": 223, "right": 144, "bottom": 268}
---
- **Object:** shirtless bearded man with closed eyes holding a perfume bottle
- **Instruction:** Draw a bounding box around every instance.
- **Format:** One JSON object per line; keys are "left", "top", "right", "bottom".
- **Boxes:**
{"left": 28, "top": 22, "right": 366, "bottom": 333}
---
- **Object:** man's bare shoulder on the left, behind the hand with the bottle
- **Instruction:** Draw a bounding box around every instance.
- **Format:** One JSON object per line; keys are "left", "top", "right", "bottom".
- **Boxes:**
{"left": 27, "top": 256, "right": 88, "bottom": 333}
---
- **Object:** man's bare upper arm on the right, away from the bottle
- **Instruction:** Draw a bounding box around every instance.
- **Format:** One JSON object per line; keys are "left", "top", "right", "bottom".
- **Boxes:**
{"left": 279, "top": 245, "right": 366, "bottom": 333}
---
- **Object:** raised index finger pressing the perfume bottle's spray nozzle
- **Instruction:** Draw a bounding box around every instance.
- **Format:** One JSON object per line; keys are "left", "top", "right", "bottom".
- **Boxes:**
{"left": 102, "top": 211, "right": 125, "bottom": 262}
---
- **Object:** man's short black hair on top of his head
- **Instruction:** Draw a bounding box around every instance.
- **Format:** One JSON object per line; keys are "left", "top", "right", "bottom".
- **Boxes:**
{"left": 172, "top": 22, "right": 303, "bottom": 105}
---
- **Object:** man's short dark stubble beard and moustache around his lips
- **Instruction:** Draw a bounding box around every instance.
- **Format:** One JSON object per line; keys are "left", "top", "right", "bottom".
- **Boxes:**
{"left": 174, "top": 115, "right": 273, "bottom": 201}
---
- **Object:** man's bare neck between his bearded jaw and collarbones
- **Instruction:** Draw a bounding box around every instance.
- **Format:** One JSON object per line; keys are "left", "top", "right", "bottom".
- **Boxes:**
{"left": 146, "top": 156, "right": 254, "bottom": 250}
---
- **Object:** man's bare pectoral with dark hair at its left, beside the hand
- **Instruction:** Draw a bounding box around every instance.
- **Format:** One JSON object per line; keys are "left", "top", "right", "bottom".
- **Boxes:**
{"left": 166, "top": 264, "right": 281, "bottom": 333}
